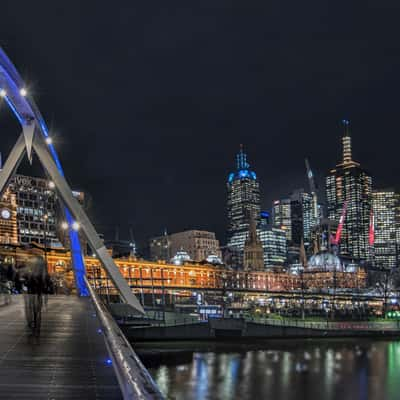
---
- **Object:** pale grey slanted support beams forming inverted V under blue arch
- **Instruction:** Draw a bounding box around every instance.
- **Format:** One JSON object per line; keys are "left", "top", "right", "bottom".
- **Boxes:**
{"left": 0, "top": 129, "right": 145, "bottom": 314}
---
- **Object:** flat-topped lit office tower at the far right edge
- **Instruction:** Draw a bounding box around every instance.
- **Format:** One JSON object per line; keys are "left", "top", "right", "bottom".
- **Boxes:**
{"left": 371, "top": 190, "right": 399, "bottom": 268}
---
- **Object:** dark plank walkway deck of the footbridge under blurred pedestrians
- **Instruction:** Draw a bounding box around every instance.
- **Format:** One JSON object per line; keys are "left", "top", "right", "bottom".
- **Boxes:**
{"left": 0, "top": 296, "right": 122, "bottom": 400}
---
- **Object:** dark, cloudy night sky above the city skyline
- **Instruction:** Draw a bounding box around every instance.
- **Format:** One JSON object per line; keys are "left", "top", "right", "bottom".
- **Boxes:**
{"left": 0, "top": 0, "right": 400, "bottom": 252}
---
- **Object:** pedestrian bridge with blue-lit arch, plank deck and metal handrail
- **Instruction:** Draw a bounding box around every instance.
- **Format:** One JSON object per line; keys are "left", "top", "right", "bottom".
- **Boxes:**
{"left": 0, "top": 47, "right": 162, "bottom": 399}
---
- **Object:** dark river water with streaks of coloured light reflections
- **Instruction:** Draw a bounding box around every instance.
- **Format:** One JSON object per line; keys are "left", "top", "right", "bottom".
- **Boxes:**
{"left": 135, "top": 339, "right": 400, "bottom": 400}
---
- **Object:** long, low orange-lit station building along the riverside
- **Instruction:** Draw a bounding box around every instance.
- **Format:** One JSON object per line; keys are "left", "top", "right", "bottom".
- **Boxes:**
{"left": 0, "top": 247, "right": 366, "bottom": 295}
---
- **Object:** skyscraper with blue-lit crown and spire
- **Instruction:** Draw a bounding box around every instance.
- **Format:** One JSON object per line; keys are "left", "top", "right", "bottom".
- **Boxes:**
{"left": 227, "top": 146, "right": 261, "bottom": 251}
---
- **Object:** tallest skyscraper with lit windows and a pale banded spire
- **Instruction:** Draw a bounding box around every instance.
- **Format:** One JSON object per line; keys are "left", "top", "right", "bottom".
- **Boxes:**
{"left": 326, "top": 120, "right": 372, "bottom": 260}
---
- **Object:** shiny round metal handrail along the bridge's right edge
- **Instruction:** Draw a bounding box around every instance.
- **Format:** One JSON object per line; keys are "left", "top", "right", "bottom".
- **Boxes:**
{"left": 85, "top": 276, "right": 164, "bottom": 400}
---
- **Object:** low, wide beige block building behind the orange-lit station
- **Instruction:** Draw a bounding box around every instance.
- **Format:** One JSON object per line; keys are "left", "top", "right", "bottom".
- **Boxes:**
{"left": 162, "top": 229, "right": 222, "bottom": 262}
